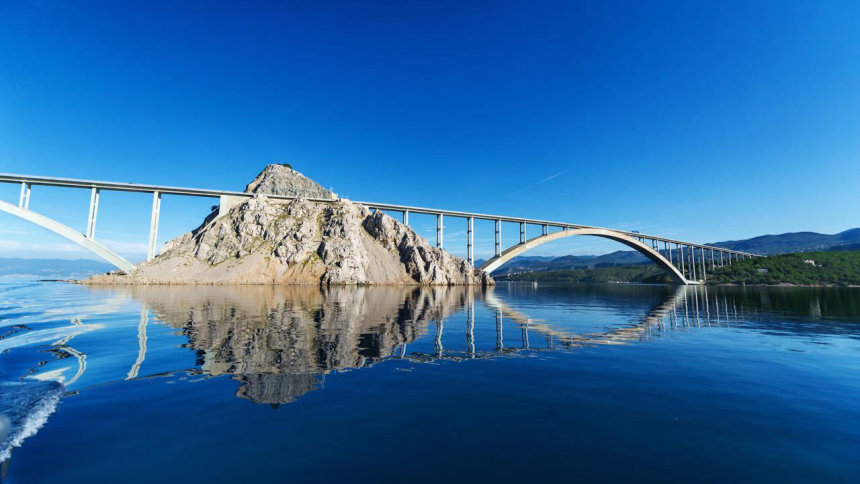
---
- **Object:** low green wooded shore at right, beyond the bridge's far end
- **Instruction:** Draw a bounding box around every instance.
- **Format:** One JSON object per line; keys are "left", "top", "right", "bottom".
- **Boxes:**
{"left": 708, "top": 251, "right": 860, "bottom": 286}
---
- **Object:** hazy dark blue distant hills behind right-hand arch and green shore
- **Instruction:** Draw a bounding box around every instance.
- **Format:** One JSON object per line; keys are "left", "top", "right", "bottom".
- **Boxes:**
{"left": 490, "top": 228, "right": 860, "bottom": 276}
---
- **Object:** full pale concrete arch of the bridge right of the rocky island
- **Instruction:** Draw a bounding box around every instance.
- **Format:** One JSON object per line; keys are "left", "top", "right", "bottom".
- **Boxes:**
{"left": 479, "top": 228, "right": 698, "bottom": 284}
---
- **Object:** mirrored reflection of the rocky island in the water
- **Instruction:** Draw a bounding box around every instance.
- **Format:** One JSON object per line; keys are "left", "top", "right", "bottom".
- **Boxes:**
{"left": 131, "top": 286, "right": 472, "bottom": 404}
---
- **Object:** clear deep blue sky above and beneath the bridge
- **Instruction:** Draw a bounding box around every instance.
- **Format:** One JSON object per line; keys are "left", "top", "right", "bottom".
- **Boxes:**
{"left": 0, "top": 1, "right": 860, "bottom": 257}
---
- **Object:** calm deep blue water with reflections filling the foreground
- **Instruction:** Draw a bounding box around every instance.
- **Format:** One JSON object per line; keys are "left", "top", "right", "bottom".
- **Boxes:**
{"left": 0, "top": 279, "right": 860, "bottom": 483}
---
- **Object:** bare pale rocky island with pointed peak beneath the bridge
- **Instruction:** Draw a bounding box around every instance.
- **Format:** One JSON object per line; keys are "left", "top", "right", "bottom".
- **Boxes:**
{"left": 89, "top": 164, "right": 493, "bottom": 285}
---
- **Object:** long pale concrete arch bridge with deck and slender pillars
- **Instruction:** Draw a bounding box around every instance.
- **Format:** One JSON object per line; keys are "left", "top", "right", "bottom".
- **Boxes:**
{"left": 0, "top": 174, "right": 756, "bottom": 284}
